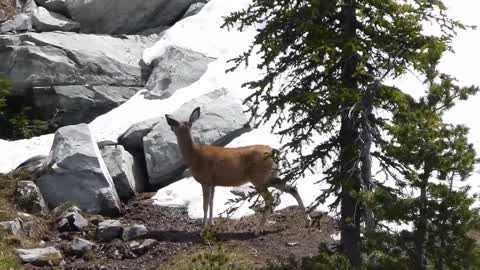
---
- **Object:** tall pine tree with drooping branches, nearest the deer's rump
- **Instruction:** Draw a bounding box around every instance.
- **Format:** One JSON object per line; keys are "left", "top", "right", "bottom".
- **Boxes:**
{"left": 225, "top": 0, "right": 465, "bottom": 268}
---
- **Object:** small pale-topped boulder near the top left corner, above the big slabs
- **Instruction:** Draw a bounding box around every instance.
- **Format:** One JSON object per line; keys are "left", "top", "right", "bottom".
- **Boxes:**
{"left": 32, "top": 7, "right": 80, "bottom": 32}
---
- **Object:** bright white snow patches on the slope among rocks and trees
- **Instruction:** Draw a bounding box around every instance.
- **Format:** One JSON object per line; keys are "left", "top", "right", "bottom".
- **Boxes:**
{"left": 0, "top": 0, "right": 480, "bottom": 218}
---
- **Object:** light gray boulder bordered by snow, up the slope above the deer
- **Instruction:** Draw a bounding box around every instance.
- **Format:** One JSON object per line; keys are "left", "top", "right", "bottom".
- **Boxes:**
{"left": 145, "top": 47, "right": 215, "bottom": 99}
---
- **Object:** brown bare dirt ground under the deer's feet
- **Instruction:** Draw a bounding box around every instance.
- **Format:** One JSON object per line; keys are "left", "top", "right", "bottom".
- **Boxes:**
{"left": 26, "top": 194, "right": 336, "bottom": 269}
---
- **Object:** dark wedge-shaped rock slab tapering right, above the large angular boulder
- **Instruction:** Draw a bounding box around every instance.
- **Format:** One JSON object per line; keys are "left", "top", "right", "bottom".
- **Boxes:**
{"left": 28, "top": 85, "right": 141, "bottom": 128}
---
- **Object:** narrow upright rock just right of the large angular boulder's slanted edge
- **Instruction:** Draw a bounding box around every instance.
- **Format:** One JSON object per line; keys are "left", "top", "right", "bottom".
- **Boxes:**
{"left": 101, "top": 145, "right": 146, "bottom": 200}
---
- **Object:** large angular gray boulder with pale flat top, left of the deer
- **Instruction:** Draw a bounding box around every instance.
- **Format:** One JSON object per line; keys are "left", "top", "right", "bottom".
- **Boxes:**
{"left": 37, "top": 124, "right": 121, "bottom": 215}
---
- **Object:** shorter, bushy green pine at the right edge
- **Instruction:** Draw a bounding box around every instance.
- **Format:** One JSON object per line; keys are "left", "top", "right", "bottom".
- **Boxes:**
{"left": 382, "top": 43, "right": 479, "bottom": 270}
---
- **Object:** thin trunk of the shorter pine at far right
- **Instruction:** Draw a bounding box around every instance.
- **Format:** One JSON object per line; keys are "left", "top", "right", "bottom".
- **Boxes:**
{"left": 415, "top": 161, "right": 432, "bottom": 270}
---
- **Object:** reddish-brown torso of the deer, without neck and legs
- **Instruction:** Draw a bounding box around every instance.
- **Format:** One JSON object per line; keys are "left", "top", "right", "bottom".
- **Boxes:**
{"left": 191, "top": 145, "right": 274, "bottom": 186}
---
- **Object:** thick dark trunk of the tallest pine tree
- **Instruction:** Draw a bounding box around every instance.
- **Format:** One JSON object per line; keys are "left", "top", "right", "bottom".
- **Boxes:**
{"left": 339, "top": 0, "right": 361, "bottom": 269}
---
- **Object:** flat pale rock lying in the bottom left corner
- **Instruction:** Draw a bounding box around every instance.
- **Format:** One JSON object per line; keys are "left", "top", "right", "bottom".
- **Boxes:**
{"left": 15, "top": 247, "right": 65, "bottom": 266}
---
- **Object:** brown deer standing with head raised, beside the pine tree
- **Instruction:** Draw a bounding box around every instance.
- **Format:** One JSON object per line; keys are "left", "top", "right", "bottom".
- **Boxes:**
{"left": 165, "top": 107, "right": 311, "bottom": 233}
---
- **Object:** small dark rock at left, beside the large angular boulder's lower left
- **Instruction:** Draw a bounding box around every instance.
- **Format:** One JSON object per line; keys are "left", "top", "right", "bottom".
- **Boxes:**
{"left": 15, "top": 181, "right": 48, "bottom": 214}
